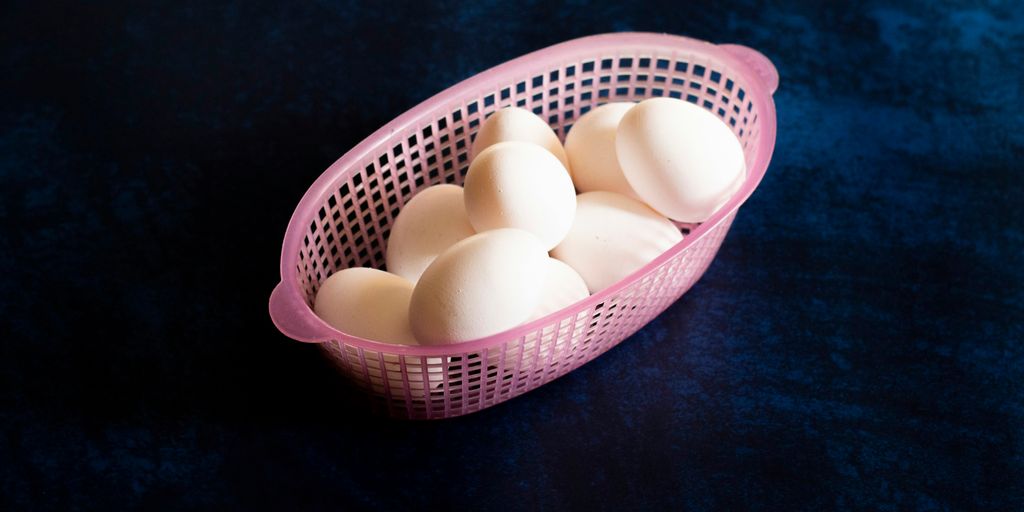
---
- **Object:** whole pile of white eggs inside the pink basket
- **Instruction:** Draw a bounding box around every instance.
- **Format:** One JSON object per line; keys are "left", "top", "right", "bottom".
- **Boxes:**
{"left": 314, "top": 98, "right": 745, "bottom": 345}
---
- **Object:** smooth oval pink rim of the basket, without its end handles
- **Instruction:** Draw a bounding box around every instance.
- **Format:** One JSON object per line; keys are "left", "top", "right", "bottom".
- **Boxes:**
{"left": 278, "top": 32, "right": 776, "bottom": 356}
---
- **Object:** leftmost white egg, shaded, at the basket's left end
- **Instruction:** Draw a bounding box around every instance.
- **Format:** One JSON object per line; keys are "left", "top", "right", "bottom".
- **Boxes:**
{"left": 313, "top": 267, "right": 416, "bottom": 345}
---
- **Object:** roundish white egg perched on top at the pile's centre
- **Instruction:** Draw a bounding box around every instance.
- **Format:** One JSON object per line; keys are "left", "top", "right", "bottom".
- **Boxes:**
{"left": 465, "top": 142, "right": 575, "bottom": 250}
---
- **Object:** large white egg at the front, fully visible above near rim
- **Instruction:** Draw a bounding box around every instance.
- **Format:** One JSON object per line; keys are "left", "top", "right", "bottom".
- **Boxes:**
{"left": 409, "top": 229, "right": 548, "bottom": 345}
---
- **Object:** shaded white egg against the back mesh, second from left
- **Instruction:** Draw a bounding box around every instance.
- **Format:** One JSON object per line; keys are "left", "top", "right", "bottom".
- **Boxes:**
{"left": 385, "top": 184, "right": 474, "bottom": 284}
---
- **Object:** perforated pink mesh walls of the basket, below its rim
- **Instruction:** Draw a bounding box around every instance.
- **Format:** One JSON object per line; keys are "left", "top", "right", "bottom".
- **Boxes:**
{"left": 295, "top": 41, "right": 760, "bottom": 418}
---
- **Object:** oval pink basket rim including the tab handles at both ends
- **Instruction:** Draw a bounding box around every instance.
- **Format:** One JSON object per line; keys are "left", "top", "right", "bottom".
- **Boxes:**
{"left": 270, "top": 32, "right": 777, "bottom": 356}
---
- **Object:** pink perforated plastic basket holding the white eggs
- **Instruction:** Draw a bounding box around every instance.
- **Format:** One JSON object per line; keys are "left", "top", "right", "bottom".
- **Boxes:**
{"left": 270, "top": 33, "right": 778, "bottom": 419}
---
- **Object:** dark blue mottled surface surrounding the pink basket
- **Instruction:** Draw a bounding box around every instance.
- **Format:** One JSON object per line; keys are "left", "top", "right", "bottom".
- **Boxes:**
{"left": 0, "top": 0, "right": 1024, "bottom": 510}
